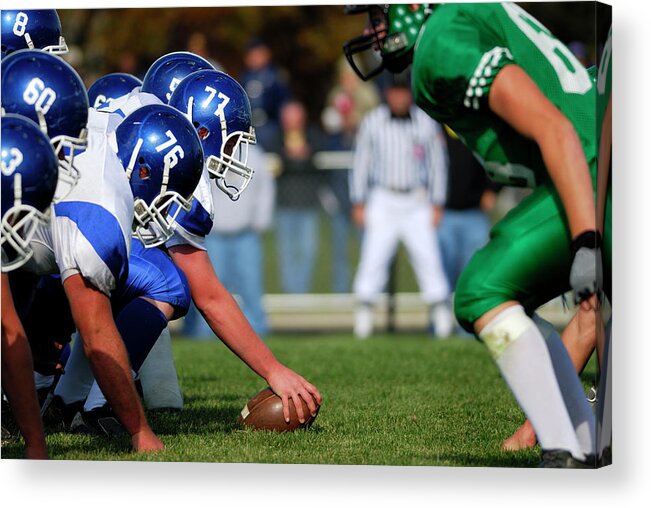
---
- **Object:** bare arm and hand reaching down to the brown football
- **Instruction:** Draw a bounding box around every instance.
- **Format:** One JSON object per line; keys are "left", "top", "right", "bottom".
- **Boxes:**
{"left": 169, "top": 244, "right": 321, "bottom": 422}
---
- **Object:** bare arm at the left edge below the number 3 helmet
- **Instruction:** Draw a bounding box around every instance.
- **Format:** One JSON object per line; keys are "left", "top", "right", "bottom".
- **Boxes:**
{"left": 2, "top": 273, "right": 48, "bottom": 459}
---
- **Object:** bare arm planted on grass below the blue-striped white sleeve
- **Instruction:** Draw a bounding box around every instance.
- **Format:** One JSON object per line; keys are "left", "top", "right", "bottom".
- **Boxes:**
{"left": 63, "top": 274, "right": 164, "bottom": 452}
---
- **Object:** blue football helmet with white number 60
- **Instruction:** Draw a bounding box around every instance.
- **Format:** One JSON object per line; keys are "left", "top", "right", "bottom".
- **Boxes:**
{"left": 0, "top": 49, "right": 88, "bottom": 200}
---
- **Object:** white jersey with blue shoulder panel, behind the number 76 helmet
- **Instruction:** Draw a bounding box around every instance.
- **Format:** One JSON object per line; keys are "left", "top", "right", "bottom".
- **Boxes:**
{"left": 25, "top": 108, "right": 133, "bottom": 295}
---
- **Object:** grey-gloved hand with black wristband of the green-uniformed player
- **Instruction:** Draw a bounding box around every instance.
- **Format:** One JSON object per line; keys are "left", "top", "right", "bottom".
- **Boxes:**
{"left": 570, "top": 231, "right": 601, "bottom": 310}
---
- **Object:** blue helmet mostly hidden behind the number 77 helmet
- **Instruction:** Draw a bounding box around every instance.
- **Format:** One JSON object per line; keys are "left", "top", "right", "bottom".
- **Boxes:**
{"left": 141, "top": 51, "right": 215, "bottom": 104}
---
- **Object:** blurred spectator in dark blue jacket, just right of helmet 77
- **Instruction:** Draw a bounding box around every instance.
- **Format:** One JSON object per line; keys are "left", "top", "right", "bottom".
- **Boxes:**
{"left": 240, "top": 37, "right": 290, "bottom": 150}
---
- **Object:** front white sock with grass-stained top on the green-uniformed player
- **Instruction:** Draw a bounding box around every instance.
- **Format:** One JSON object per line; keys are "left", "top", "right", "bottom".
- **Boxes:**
{"left": 479, "top": 305, "right": 585, "bottom": 460}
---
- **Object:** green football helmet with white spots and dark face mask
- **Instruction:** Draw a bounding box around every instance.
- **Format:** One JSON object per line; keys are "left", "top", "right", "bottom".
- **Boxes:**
{"left": 344, "top": 4, "right": 432, "bottom": 81}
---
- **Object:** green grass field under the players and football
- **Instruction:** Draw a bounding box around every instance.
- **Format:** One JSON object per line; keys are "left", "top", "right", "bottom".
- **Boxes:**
{"left": 2, "top": 335, "right": 594, "bottom": 467}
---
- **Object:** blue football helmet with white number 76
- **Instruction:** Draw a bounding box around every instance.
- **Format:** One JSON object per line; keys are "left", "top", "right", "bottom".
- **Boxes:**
{"left": 115, "top": 104, "right": 203, "bottom": 247}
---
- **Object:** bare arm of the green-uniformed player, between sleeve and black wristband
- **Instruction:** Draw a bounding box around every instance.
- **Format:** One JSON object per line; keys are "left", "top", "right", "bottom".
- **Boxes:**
{"left": 489, "top": 65, "right": 596, "bottom": 237}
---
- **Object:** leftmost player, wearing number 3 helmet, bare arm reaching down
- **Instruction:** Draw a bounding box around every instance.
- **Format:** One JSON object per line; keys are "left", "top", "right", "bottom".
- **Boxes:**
{"left": 0, "top": 114, "right": 59, "bottom": 459}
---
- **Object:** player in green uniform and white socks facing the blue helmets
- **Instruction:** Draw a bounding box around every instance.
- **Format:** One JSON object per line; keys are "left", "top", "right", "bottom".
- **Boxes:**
{"left": 344, "top": 3, "right": 610, "bottom": 467}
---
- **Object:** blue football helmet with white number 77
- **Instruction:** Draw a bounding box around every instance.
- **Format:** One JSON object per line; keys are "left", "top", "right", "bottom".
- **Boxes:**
{"left": 169, "top": 71, "right": 256, "bottom": 200}
